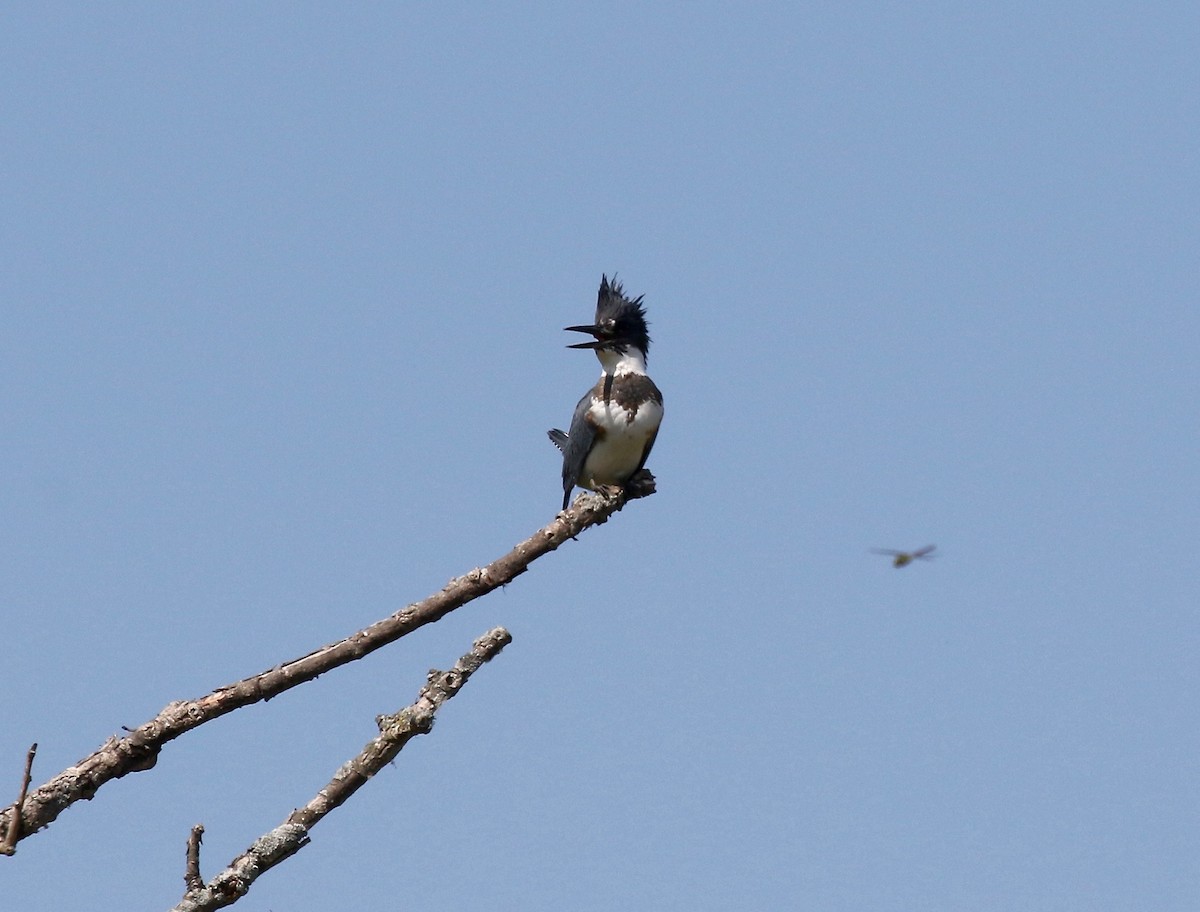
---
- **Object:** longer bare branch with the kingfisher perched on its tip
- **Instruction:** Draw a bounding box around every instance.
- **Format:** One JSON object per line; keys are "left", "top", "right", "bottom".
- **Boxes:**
{"left": 0, "top": 484, "right": 654, "bottom": 839}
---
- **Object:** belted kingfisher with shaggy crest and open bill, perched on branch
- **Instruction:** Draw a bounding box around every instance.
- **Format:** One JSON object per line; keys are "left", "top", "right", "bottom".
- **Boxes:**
{"left": 547, "top": 276, "right": 662, "bottom": 510}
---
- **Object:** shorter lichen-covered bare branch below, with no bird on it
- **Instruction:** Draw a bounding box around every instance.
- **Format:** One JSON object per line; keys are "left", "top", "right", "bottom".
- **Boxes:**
{"left": 172, "top": 628, "right": 512, "bottom": 912}
